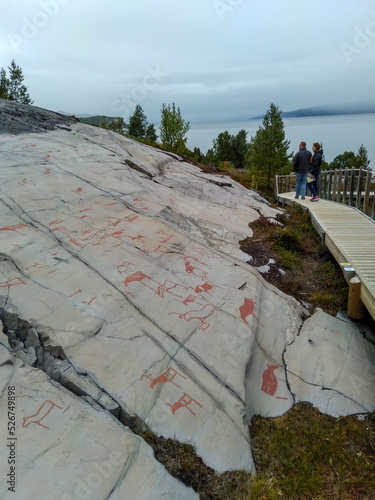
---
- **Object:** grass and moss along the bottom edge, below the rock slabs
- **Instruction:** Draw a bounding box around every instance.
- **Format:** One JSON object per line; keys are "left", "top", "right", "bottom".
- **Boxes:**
{"left": 141, "top": 403, "right": 375, "bottom": 500}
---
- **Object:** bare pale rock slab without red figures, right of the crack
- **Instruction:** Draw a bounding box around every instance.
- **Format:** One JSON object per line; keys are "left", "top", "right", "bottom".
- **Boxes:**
{"left": 285, "top": 310, "right": 375, "bottom": 417}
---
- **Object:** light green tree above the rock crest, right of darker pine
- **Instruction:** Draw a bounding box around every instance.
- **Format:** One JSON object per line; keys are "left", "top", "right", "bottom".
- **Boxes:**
{"left": 160, "top": 103, "right": 190, "bottom": 153}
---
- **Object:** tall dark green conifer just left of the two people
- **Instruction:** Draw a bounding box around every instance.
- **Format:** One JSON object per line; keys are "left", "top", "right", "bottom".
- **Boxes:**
{"left": 245, "top": 103, "right": 291, "bottom": 188}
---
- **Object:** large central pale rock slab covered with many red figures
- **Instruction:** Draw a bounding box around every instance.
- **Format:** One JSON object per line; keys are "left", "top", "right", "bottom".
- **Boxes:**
{"left": 0, "top": 107, "right": 373, "bottom": 498}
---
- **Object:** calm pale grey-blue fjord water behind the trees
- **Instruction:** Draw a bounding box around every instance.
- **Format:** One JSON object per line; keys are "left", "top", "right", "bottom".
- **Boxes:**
{"left": 187, "top": 113, "right": 375, "bottom": 165}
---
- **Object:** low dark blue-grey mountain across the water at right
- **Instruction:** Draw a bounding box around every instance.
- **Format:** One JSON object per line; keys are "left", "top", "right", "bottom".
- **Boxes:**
{"left": 250, "top": 103, "right": 375, "bottom": 120}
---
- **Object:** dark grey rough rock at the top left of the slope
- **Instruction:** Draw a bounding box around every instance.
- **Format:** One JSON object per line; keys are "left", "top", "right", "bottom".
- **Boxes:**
{"left": 0, "top": 99, "right": 74, "bottom": 134}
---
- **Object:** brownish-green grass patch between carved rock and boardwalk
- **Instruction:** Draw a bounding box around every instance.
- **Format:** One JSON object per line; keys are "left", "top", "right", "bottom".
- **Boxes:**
{"left": 240, "top": 205, "right": 348, "bottom": 315}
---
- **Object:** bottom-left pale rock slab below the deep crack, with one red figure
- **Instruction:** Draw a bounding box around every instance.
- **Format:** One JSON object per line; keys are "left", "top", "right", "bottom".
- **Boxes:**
{"left": 0, "top": 346, "right": 199, "bottom": 500}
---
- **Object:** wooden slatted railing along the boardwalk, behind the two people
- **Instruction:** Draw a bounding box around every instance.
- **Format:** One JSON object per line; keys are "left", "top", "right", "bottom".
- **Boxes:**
{"left": 275, "top": 168, "right": 375, "bottom": 220}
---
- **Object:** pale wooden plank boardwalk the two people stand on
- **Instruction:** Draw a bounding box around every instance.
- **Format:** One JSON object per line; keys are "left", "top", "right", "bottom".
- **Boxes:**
{"left": 278, "top": 191, "right": 375, "bottom": 320}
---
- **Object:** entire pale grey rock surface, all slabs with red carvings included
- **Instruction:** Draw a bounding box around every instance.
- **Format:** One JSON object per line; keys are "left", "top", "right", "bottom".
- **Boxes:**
{"left": 0, "top": 102, "right": 375, "bottom": 500}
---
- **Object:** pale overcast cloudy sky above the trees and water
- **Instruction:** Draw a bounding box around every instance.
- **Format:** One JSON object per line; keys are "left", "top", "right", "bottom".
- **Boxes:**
{"left": 0, "top": 0, "right": 375, "bottom": 123}
